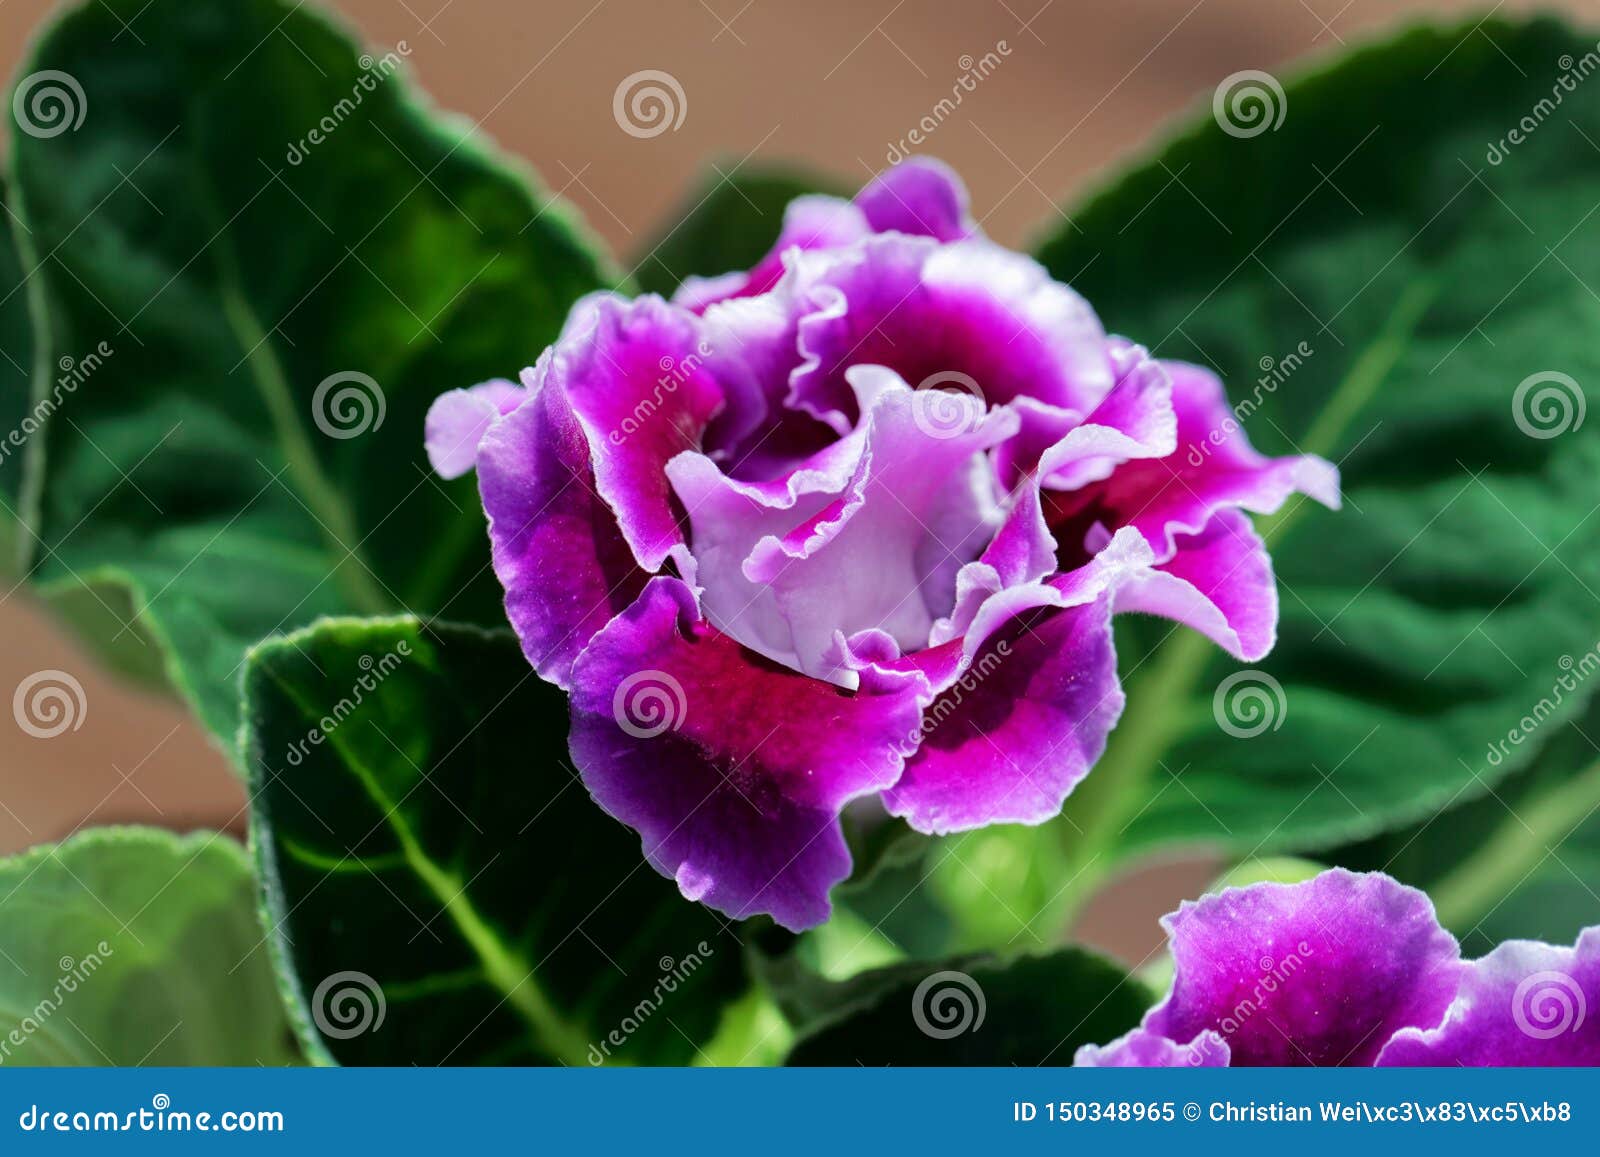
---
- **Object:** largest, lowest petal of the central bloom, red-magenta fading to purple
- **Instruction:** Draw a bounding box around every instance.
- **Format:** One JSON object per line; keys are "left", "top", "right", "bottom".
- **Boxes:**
{"left": 571, "top": 578, "right": 925, "bottom": 931}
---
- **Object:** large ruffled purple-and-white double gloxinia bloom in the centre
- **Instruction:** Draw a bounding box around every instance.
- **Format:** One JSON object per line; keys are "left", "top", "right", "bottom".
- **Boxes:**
{"left": 427, "top": 162, "right": 1338, "bottom": 930}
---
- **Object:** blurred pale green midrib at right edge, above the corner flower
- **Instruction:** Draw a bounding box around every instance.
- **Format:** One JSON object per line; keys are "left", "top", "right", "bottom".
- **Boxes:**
{"left": 1429, "top": 760, "right": 1600, "bottom": 928}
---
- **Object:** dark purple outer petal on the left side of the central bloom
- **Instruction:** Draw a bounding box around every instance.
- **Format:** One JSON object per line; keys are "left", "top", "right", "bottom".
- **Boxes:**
{"left": 478, "top": 360, "right": 646, "bottom": 688}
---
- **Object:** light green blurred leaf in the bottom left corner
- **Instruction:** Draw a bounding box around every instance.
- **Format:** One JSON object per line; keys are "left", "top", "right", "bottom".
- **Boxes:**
{"left": 0, "top": 827, "right": 299, "bottom": 1066}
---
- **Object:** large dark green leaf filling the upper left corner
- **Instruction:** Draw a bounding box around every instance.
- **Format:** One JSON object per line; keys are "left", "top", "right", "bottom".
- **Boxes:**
{"left": 8, "top": 0, "right": 614, "bottom": 752}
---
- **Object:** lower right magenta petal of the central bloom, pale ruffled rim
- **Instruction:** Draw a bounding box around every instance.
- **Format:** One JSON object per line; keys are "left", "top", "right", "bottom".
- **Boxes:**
{"left": 883, "top": 531, "right": 1150, "bottom": 835}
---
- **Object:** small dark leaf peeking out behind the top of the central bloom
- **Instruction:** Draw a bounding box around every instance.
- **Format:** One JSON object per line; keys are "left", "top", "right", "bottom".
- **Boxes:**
{"left": 634, "top": 165, "right": 838, "bottom": 296}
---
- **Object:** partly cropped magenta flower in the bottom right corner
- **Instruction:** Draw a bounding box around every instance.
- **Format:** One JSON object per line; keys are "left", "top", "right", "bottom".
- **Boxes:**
{"left": 1077, "top": 869, "right": 1600, "bottom": 1067}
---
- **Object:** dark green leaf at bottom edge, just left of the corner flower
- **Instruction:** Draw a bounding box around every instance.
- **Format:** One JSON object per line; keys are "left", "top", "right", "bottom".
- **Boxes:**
{"left": 789, "top": 949, "right": 1154, "bottom": 1066}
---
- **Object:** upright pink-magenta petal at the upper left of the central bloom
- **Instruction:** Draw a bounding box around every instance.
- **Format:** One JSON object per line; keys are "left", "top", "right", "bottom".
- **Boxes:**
{"left": 547, "top": 294, "right": 728, "bottom": 571}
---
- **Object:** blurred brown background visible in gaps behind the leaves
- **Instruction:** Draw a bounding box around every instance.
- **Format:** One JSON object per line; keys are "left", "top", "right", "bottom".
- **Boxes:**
{"left": 0, "top": 0, "right": 1580, "bottom": 959}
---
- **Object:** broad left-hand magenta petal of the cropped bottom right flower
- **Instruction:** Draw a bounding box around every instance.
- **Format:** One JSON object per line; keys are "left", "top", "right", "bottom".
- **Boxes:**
{"left": 1144, "top": 869, "right": 1462, "bottom": 1066}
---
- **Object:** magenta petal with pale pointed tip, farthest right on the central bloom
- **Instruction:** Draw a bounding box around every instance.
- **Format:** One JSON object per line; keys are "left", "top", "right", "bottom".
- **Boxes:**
{"left": 1046, "top": 362, "right": 1339, "bottom": 560}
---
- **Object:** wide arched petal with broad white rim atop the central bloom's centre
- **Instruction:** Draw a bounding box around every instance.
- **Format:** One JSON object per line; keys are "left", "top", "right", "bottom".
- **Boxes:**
{"left": 789, "top": 234, "right": 1114, "bottom": 434}
